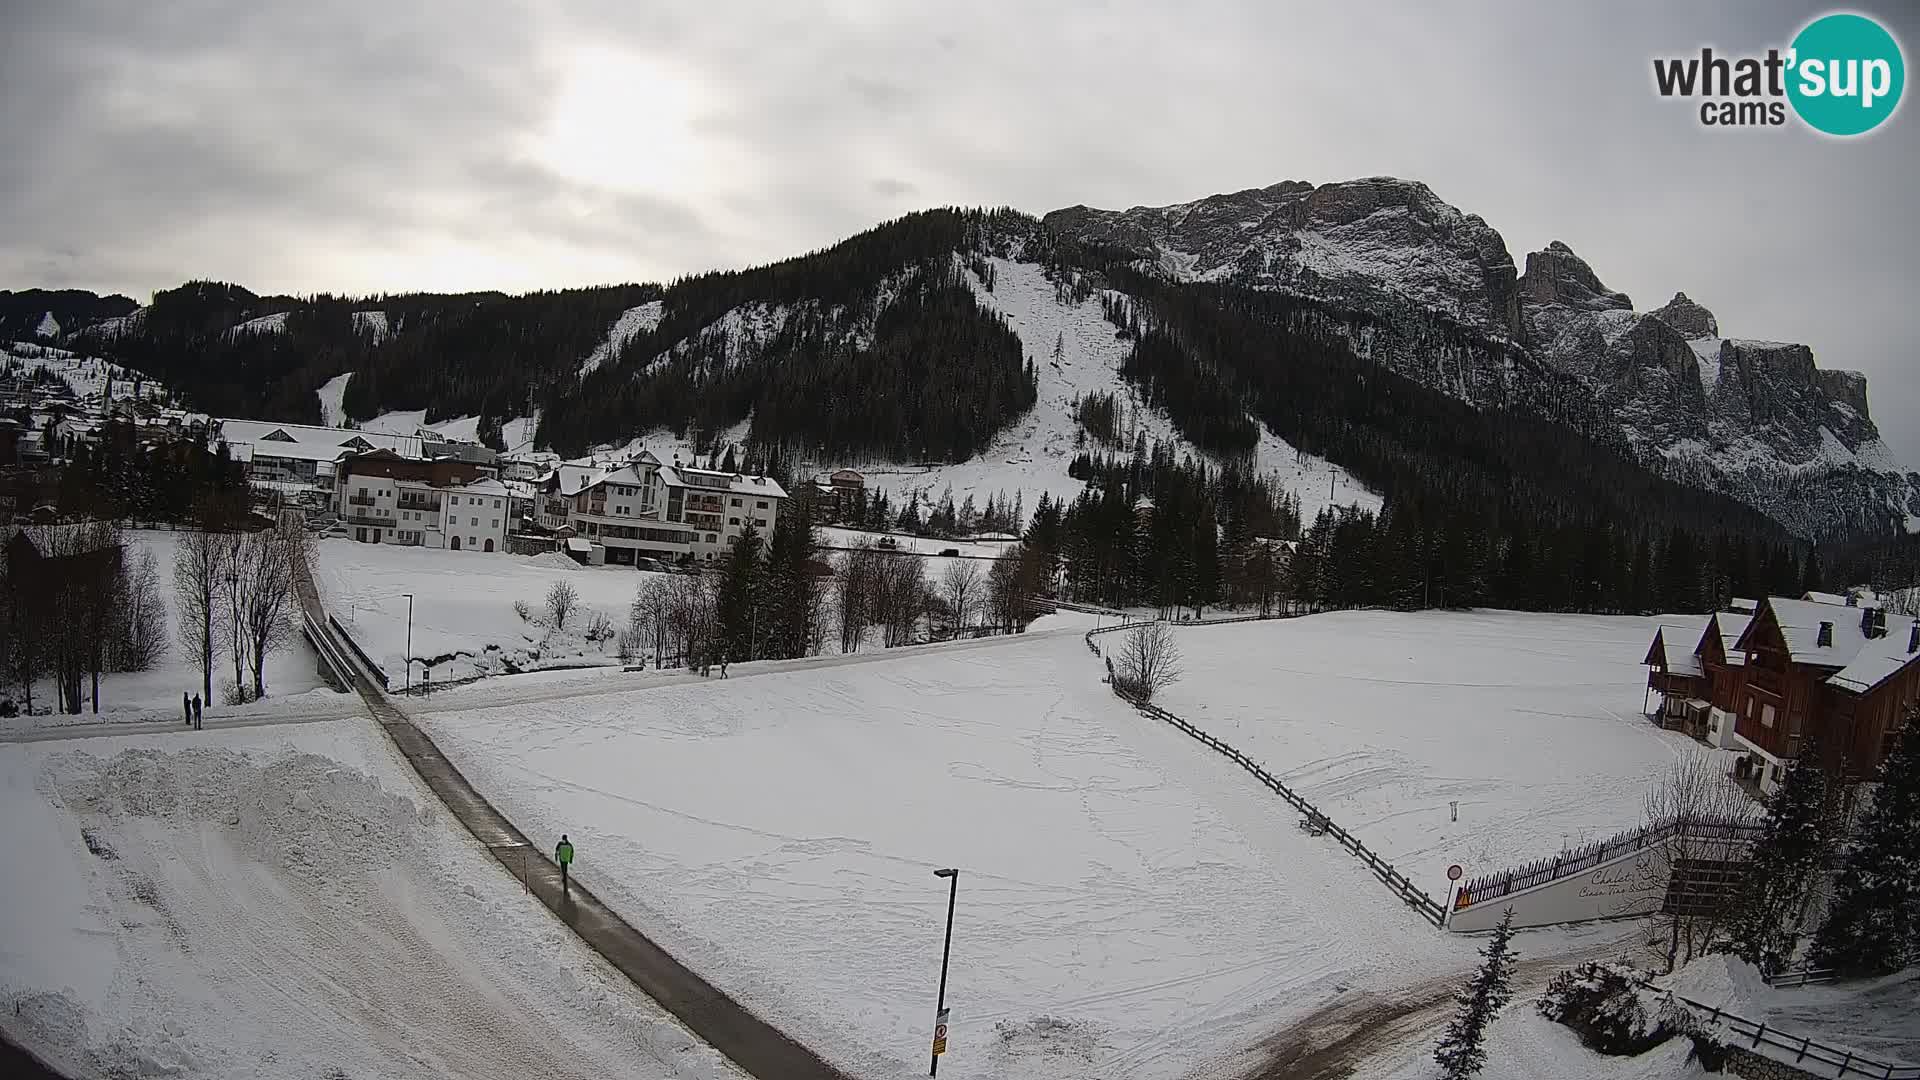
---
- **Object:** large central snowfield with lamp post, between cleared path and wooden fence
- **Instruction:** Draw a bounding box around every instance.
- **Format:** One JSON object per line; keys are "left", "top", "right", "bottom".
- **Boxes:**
{"left": 419, "top": 615, "right": 1473, "bottom": 1080}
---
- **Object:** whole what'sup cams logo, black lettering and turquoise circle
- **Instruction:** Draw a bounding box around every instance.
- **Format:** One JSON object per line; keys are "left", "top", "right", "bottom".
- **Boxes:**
{"left": 1653, "top": 13, "right": 1907, "bottom": 136}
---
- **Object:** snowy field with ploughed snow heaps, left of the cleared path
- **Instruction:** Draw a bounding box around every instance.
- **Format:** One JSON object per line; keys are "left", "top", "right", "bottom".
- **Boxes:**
{"left": 0, "top": 719, "right": 737, "bottom": 1080}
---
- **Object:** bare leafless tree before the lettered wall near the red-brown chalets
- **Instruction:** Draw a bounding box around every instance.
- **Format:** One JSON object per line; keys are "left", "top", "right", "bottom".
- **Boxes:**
{"left": 1645, "top": 753, "right": 1753, "bottom": 972}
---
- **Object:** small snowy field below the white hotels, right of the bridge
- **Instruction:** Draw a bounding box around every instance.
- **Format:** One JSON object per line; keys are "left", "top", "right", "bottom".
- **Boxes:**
{"left": 313, "top": 540, "right": 655, "bottom": 688}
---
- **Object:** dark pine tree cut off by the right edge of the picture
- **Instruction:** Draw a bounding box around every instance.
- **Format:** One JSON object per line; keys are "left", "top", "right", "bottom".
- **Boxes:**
{"left": 1812, "top": 711, "right": 1920, "bottom": 976}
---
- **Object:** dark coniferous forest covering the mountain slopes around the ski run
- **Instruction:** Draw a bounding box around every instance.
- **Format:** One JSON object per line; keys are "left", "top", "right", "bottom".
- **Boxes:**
{"left": 37, "top": 209, "right": 1850, "bottom": 611}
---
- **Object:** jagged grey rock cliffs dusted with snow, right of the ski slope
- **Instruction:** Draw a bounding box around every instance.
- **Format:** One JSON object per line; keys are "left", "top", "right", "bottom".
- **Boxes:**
{"left": 1046, "top": 177, "right": 1920, "bottom": 536}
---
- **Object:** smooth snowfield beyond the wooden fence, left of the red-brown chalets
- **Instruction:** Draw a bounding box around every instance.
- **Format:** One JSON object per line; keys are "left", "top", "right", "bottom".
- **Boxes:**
{"left": 1152, "top": 611, "right": 1709, "bottom": 899}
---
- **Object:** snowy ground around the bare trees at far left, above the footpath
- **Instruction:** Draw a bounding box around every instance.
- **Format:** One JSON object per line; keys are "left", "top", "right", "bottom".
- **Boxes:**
{"left": 0, "top": 530, "right": 338, "bottom": 732}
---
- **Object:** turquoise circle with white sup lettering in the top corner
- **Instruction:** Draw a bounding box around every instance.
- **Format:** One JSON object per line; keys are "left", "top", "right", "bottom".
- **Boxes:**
{"left": 1788, "top": 13, "right": 1907, "bottom": 136}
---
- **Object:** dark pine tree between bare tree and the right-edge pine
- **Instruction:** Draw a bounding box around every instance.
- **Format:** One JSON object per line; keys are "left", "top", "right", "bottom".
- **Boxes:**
{"left": 1728, "top": 740, "right": 1834, "bottom": 974}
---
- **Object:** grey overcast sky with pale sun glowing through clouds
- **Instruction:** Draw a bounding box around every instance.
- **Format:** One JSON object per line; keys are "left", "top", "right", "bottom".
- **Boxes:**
{"left": 0, "top": 0, "right": 1920, "bottom": 457}
